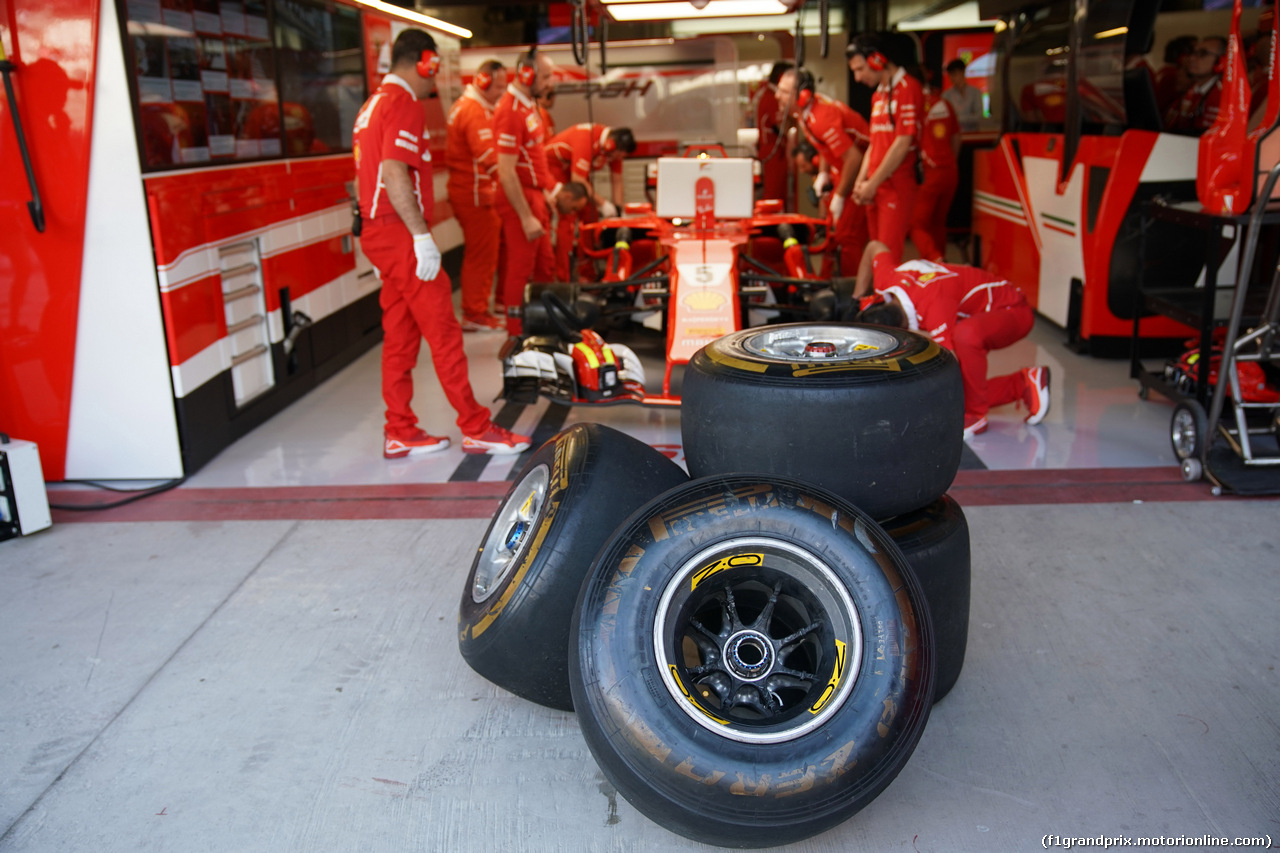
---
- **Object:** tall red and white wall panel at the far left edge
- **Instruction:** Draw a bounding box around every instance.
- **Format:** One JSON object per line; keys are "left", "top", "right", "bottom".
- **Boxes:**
{"left": 0, "top": 0, "right": 182, "bottom": 480}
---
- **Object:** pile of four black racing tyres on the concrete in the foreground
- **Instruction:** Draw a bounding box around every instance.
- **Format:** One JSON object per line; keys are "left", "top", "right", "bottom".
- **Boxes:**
{"left": 460, "top": 324, "right": 969, "bottom": 847}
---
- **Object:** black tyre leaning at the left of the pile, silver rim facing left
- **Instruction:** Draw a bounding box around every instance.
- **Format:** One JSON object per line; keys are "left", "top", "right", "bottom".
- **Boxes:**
{"left": 458, "top": 424, "right": 689, "bottom": 711}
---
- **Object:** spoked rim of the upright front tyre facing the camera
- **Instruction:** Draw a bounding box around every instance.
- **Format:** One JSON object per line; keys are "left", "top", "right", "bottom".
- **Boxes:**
{"left": 653, "top": 537, "right": 863, "bottom": 744}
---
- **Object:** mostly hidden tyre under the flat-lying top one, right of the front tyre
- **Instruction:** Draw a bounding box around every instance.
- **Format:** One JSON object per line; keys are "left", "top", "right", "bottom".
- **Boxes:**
{"left": 881, "top": 494, "right": 972, "bottom": 702}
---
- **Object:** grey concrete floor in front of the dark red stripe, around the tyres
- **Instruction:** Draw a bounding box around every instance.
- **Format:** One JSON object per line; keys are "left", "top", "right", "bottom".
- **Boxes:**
{"left": 0, "top": 500, "right": 1280, "bottom": 853}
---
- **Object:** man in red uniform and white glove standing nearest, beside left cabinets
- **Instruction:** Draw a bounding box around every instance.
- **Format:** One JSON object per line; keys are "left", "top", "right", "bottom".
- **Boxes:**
{"left": 352, "top": 29, "right": 530, "bottom": 459}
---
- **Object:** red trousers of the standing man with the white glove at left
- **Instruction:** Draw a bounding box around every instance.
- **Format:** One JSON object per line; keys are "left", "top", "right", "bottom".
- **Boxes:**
{"left": 360, "top": 219, "right": 489, "bottom": 438}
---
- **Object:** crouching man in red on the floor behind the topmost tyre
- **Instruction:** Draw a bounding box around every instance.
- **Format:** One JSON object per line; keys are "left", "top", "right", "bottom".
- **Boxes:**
{"left": 858, "top": 240, "right": 1050, "bottom": 439}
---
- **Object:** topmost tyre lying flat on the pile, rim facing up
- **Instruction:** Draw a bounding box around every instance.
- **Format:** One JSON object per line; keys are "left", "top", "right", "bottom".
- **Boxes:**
{"left": 680, "top": 323, "right": 964, "bottom": 519}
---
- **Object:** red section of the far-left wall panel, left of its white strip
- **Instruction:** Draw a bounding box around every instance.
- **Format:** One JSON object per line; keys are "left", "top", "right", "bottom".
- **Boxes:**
{"left": 0, "top": 0, "right": 99, "bottom": 480}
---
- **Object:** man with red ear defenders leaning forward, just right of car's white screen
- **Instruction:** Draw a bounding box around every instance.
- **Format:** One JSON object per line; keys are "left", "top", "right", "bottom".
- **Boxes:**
{"left": 778, "top": 68, "right": 869, "bottom": 278}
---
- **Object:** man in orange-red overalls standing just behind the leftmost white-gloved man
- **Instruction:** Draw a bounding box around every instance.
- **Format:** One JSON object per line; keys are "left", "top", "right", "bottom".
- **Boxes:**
{"left": 444, "top": 59, "right": 507, "bottom": 332}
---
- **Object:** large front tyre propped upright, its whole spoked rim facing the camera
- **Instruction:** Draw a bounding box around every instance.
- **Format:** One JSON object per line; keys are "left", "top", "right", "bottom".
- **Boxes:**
{"left": 570, "top": 475, "right": 933, "bottom": 847}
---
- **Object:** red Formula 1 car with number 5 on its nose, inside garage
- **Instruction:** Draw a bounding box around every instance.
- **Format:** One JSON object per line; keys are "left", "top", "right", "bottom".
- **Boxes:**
{"left": 500, "top": 146, "right": 852, "bottom": 406}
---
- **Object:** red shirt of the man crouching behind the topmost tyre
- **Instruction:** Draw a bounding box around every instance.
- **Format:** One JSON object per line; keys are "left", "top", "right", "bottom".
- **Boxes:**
{"left": 876, "top": 252, "right": 1027, "bottom": 350}
